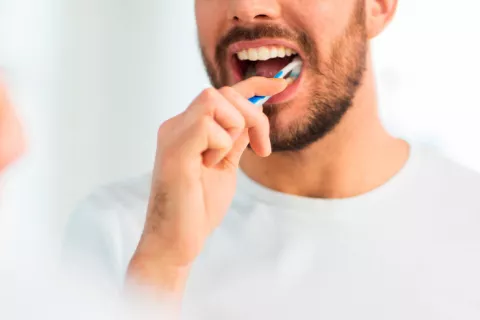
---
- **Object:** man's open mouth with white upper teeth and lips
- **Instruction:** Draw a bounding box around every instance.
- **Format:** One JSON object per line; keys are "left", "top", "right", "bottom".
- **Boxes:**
{"left": 231, "top": 42, "right": 302, "bottom": 103}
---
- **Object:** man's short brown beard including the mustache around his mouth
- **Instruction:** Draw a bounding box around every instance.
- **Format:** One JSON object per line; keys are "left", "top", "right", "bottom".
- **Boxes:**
{"left": 201, "top": 0, "right": 368, "bottom": 152}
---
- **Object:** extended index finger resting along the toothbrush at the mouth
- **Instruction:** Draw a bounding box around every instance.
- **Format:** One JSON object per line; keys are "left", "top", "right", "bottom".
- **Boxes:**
{"left": 232, "top": 77, "right": 288, "bottom": 99}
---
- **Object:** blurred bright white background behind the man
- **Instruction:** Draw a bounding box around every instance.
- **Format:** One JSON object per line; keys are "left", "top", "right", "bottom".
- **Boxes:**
{"left": 0, "top": 0, "right": 480, "bottom": 255}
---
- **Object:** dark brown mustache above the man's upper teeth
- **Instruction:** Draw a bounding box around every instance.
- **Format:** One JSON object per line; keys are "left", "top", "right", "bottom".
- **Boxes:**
{"left": 215, "top": 24, "right": 317, "bottom": 67}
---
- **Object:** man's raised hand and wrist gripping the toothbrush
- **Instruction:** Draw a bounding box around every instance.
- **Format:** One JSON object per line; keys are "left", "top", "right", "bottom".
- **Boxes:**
{"left": 125, "top": 77, "right": 287, "bottom": 292}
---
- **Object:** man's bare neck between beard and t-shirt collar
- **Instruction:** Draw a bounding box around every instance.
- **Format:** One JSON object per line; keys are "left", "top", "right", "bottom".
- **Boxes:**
{"left": 240, "top": 59, "right": 409, "bottom": 198}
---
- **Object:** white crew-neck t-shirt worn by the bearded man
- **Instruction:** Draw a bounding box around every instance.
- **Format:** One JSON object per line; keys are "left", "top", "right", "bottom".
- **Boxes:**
{"left": 65, "top": 146, "right": 480, "bottom": 320}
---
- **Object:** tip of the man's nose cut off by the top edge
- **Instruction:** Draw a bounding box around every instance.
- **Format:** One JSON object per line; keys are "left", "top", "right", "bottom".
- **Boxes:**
{"left": 229, "top": 0, "right": 281, "bottom": 24}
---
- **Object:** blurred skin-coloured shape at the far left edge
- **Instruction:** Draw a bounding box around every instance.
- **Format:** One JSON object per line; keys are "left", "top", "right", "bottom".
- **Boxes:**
{"left": 0, "top": 82, "right": 25, "bottom": 173}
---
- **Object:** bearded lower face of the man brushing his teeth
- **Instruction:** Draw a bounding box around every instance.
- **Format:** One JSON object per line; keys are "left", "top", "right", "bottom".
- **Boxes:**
{"left": 195, "top": 0, "right": 367, "bottom": 152}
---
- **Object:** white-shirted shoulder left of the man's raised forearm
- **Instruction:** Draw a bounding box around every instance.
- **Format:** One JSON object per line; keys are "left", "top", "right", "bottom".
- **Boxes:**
{"left": 62, "top": 175, "right": 150, "bottom": 281}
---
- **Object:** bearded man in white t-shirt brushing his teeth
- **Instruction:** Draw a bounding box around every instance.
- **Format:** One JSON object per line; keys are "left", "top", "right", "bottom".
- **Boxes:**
{"left": 63, "top": 0, "right": 480, "bottom": 319}
